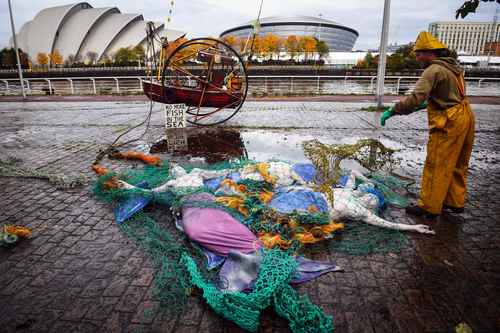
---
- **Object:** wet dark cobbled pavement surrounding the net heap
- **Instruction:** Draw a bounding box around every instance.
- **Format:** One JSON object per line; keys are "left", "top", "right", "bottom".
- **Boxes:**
{"left": 0, "top": 100, "right": 500, "bottom": 333}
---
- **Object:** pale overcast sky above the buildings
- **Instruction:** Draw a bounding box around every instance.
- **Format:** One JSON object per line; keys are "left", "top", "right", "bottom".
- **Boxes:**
{"left": 0, "top": 0, "right": 498, "bottom": 49}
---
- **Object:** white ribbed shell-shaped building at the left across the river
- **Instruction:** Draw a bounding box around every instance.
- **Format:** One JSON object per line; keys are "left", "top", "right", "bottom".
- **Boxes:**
{"left": 10, "top": 2, "right": 184, "bottom": 61}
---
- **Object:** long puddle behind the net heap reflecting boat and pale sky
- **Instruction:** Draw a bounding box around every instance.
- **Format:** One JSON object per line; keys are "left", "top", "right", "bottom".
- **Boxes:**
{"left": 149, "top": 127, "right": 425, "bottom": 174}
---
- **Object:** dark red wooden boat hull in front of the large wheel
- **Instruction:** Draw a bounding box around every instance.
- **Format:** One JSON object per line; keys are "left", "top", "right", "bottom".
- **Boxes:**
{"left": 142, "top": 81, "right": 242, "bottom": 109}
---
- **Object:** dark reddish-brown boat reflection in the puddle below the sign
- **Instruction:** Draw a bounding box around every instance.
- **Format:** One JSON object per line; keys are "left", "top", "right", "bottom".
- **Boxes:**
{"left": 150, "top": 128, "right": 247, "bottom": 163}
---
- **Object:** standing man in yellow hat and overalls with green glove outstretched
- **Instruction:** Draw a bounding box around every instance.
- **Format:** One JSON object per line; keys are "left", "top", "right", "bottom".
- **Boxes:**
{"left": 381, "top": 31, "right": 475, "bottom": 218}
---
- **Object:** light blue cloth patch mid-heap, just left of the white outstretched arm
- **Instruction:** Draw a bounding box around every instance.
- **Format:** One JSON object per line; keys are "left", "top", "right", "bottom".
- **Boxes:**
{"left": 269, "top": 186, "right": 328, "bottom": 213}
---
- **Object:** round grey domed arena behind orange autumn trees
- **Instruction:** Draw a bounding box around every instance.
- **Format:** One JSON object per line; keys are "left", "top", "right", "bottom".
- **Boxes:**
{"left": 220, "top": 16, "right": 359, "bottom": 51}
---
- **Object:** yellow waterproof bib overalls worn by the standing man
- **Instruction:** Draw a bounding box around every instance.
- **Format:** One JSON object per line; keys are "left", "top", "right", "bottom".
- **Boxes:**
{"left": 417, "top": 75, "right": 475, "bottom": 214}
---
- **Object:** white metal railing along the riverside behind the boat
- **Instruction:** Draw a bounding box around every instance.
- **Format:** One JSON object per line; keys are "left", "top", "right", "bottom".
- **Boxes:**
{"left": 0, "top": 75, "right": 500, "bottom": 96}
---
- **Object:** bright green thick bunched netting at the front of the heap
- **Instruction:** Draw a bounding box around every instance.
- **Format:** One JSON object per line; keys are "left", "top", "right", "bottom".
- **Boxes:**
{"left": 182, "top": 250, "right": 333, "bottom": 333}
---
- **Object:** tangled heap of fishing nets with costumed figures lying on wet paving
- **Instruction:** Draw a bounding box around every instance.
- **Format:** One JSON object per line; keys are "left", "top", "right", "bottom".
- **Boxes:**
{"left": 94, "top": 137, "right": 422, "bottom": 332}
